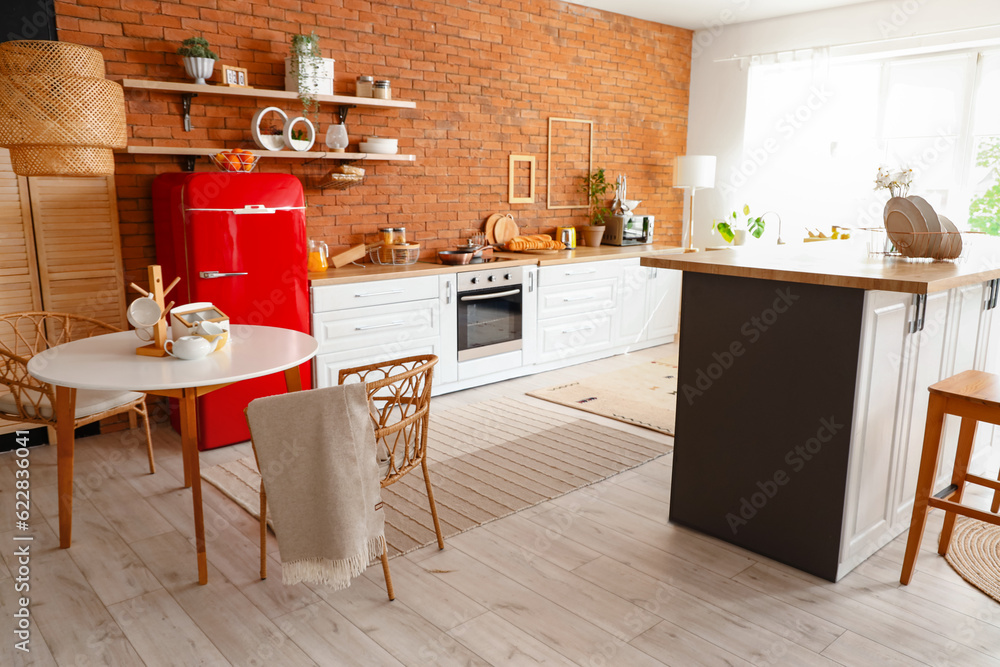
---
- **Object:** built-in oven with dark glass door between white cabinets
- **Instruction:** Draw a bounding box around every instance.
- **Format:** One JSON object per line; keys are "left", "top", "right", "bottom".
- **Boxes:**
{"left": 457, "top": 266, "right": 523, "bottom": 362}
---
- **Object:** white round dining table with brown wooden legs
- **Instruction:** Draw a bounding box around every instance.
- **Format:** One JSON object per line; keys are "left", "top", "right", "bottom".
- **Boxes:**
{"left": 28, "top": 324, "right": 319, "bottom": 584}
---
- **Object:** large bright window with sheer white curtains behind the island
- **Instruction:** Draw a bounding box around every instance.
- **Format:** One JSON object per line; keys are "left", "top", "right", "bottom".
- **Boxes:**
{"left": 748, "top": 47, "right": 1000, "bottom": 234}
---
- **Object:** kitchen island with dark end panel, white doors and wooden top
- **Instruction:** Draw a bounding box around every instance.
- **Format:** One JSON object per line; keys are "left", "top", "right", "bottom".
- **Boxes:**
{"left": 642, "top": 238, "right": 1000, "bottom": 581}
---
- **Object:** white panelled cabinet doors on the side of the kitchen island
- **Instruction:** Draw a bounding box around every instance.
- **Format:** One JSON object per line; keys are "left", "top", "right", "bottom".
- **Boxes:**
{"left": 839, "top": 285, "right": 1000, "bottom": 572}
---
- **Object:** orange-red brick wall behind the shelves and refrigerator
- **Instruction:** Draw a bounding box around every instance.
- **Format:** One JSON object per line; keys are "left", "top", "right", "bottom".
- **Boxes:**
{"left": 56, "top": 0, "right": 692, "bottom": 282}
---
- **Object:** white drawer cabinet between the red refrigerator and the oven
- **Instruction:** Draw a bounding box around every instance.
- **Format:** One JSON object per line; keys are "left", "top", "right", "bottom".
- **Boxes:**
{"left": 312, "top": 274, "right": 457, "bottom": 387}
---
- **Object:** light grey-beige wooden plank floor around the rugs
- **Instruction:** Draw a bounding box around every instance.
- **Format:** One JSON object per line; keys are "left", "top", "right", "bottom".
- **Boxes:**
{"left": 0, "top": 347, "right": 1000, "bottom": 667}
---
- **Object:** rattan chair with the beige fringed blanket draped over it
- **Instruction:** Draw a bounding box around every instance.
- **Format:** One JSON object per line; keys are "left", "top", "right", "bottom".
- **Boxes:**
{"left": 254, "top": 354, "right": 444, "bottom": 600}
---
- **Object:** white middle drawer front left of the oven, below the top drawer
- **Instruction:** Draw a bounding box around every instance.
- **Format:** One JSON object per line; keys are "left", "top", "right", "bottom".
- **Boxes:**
{"left": 313, "top": 298, "right": 441, "bottom": 352}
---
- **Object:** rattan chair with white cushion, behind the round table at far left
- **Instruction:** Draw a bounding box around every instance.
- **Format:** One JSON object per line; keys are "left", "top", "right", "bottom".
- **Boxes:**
{"left": 0, "top": 311, "right": 156, "bottom": 473}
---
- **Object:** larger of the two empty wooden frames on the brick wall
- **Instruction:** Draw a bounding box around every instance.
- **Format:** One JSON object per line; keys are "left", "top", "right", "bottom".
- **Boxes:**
{"left": 545, "top": 118, "right": 594, "bottom": 208}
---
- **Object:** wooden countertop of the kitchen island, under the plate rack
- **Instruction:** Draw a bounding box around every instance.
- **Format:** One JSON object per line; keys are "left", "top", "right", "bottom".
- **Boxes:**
{"left": 642, "top": 239, "right": 1000, "bottom": 294}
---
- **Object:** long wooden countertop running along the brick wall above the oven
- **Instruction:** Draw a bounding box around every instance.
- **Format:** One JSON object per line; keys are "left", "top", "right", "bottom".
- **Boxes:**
{"left": 309, "top": 244, "right": 684, "bottom": 286}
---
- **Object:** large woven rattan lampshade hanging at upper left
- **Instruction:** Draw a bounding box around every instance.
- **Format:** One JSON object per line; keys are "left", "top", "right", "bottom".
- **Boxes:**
{"left": 0, "top": 40, "right": 126, "bottom": 176}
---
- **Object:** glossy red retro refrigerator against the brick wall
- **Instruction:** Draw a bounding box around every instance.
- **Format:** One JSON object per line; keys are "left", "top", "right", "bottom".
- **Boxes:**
{"left": 153, "top": 172, "right": 312, "bottom": 450}
